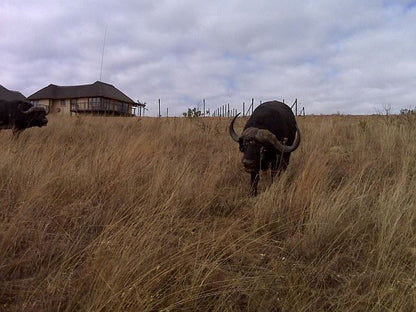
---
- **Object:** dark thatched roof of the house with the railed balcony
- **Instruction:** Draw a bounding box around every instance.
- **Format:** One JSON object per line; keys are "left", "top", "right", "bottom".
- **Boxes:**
{"left": 28, "top": 81, "right": 135, "bottom": 104}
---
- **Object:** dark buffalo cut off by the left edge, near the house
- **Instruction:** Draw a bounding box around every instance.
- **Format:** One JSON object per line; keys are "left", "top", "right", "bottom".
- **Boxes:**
{"left": 0, "top": 100, "right": 49, "bottom": 134}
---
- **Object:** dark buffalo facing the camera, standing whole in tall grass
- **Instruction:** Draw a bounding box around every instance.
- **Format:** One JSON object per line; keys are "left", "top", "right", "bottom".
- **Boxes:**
{"left": 229, "top": 101, "right": 300, "bottom": 196}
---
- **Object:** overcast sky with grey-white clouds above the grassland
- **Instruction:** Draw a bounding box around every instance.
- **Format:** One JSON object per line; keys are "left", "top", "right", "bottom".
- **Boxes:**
{"left": 0, "top": 0, "right": 416, "bottom": 116}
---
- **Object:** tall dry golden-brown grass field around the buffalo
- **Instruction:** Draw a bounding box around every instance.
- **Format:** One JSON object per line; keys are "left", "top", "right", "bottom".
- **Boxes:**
{"left": 0, "top": 116, "right": 416, "bottom": 312}
